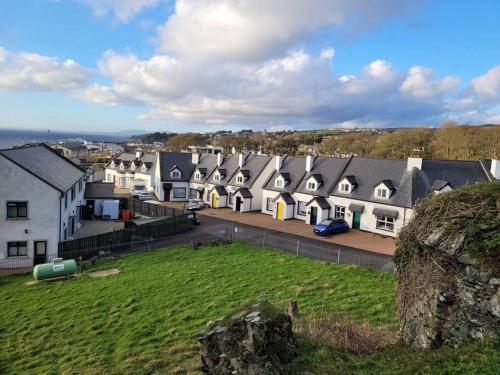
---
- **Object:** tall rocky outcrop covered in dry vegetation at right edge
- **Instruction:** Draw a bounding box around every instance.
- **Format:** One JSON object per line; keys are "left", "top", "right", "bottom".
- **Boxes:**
{"left": 394, "top": 184, "right": 500, "bottom": 348}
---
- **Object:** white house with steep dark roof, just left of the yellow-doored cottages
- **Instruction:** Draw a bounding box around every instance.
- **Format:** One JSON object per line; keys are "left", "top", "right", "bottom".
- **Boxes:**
{"left": 154, "top": 152, "right": 195, "bottom": 201}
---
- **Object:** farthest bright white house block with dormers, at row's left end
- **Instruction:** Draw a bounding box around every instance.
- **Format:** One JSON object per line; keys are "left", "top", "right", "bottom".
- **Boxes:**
{"left": 105, "top": 148, "right": 157, "bottom": 191}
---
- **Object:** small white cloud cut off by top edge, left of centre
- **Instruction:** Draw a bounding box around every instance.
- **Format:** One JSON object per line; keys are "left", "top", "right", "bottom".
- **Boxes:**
{"left": 78, "top": 0, "right": 160, "bottom": 22}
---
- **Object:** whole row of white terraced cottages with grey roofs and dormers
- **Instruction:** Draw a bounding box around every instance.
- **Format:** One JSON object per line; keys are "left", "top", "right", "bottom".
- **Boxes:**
{"left": 106, "top": 150, "right": 500, "bottom": 236}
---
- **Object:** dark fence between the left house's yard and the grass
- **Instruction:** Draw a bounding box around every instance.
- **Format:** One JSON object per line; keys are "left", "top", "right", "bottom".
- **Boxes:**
{"left": 58, "top": 213, "right": 193, "bottom": 260}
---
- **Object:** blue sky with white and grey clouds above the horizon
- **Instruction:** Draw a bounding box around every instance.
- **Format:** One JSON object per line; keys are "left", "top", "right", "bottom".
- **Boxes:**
{"left": 0, "top": 0, "right": 500, "bottom": 132}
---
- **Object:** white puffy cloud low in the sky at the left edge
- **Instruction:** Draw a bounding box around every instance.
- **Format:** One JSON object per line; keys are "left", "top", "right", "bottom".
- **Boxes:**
{"left": 0, "top": 47, "right": 88, "bottom": 91}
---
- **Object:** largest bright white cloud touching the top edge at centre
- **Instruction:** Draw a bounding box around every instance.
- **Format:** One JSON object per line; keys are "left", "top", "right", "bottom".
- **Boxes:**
{"left": 158, "top": 0, "right": 411, "bottom": 61}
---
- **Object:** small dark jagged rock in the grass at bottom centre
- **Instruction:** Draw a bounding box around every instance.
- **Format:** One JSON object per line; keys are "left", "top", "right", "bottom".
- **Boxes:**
{"left": 197, "top": 301, "right": 297, "bottom": 375}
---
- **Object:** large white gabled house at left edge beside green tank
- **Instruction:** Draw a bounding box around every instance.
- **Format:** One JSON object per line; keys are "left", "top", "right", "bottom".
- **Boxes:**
{"left": 0, "top": 144, "right": 85, "bottom": 267}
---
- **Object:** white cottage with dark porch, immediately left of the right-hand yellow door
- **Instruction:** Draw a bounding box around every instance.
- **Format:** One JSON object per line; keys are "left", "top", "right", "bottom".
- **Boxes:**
{"left": 227, "top": 154, "right": 274, "bottom": 212}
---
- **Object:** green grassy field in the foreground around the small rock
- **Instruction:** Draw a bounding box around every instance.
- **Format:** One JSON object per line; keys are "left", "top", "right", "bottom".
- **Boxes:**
{"left": 0, "top": 243, "right": 500, "bottom": 374}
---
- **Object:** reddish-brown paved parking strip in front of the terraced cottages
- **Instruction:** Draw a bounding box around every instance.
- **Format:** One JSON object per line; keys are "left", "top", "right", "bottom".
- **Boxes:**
{"left": 158, "top": 202, "right": 396, "bottom": 255}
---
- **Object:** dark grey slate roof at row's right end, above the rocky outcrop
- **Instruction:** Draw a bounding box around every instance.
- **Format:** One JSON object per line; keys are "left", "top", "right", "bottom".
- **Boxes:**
{"left": 413, "top": 160, "right": 488, "bottom": 201}
